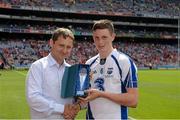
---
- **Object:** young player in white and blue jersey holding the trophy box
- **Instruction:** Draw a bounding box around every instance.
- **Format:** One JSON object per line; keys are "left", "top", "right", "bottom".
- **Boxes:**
{"left": 84, "top": 20, "right": 138, "bottom": 119}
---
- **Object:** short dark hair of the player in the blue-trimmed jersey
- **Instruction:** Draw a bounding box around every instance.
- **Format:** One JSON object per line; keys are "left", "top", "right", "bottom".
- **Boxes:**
{"left": 92, "top": 19, "right": 114, "bottom": 33}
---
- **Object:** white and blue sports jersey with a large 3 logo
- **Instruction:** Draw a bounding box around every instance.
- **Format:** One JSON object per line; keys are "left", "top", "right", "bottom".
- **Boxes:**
{"left": 86, "top": 49, "right": 137, "bottom": 119}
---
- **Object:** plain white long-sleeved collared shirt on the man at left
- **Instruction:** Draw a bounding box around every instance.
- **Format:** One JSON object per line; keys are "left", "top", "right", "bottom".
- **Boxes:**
{"left": 26, "top": 54, "right": 73, "bottom": 119}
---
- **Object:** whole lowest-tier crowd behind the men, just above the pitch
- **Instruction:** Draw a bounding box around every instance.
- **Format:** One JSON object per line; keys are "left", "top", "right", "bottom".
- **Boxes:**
{"left": 0, "top": 39, "right": 178, "bottom": 68}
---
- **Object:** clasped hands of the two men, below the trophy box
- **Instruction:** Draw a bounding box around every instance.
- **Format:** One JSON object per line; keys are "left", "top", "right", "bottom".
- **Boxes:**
{"left": 63, "top": 104, "right": 80, "bottom": 119}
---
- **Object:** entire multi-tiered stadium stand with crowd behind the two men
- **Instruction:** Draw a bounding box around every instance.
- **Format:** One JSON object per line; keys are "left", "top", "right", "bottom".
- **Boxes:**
{"left": 0, "top": 0, "right": 180, "bottom": 69}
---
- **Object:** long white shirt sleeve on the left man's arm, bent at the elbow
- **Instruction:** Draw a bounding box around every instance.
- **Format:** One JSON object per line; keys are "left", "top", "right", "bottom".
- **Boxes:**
{"left": 26, "top": 64, "right": 64, "bottom": 115}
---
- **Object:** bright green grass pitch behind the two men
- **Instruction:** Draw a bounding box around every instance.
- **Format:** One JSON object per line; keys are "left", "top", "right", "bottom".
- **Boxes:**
{"left": 0, "top": 70, "right": 180, "bottom": 119}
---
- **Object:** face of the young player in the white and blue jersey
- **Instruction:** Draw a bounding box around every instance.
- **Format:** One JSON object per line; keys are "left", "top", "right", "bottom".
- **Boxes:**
{"left": 93, "top": 29, "right": 115, "bottom": 54}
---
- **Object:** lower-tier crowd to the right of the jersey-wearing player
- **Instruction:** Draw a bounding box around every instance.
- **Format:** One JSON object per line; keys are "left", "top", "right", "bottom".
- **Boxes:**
{"left": 115, "top": 42, "right": 178, "bottom": 67}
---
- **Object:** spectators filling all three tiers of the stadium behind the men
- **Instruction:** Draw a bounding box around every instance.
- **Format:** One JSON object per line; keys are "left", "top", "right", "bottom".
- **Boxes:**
{"left": 0, "top": 0, "right": 180, "bottom": 67}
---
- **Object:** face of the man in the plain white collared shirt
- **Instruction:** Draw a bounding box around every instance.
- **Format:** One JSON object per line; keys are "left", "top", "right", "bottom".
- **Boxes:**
{"left": 50, "top": 36, "right": 73, "bottom": 64}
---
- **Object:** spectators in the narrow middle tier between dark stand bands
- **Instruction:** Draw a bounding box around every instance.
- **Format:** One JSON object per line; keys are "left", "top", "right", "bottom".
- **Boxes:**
{"left": 0, "top": 23, "right": 178, "bottom": 38}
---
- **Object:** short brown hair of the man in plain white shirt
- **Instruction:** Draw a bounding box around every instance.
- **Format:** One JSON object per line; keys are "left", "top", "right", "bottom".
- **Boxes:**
{"left": 51, "top": 28, "right": 75, "bottom": 41}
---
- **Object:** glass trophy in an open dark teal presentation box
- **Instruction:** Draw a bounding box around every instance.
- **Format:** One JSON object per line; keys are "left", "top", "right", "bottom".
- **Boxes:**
{"left": 61, "top": 64, "right": 90, "bottom": 98}
